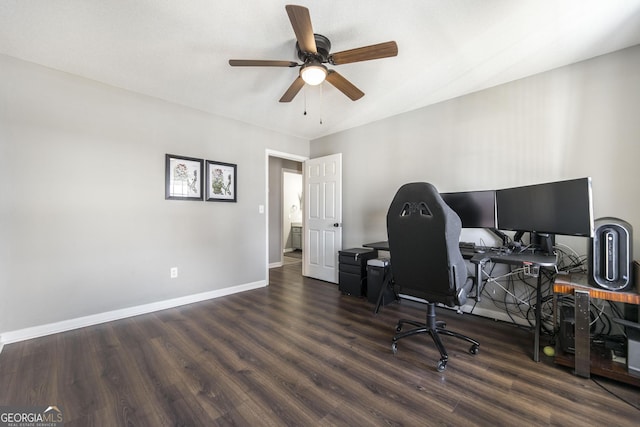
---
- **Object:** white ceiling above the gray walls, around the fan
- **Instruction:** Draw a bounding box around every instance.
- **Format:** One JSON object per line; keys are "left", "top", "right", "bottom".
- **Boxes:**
{"left": 0, "top": 0, "right": 640, "bottom": 140}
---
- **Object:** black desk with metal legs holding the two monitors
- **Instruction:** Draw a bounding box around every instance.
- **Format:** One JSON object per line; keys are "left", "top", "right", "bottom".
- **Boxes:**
{"left": 362, "top": 241, "right": 556, "bottom": 362}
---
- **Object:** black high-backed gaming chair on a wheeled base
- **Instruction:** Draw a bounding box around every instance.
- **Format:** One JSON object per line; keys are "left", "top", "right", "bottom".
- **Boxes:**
{"left": 387, "top": 182, "right": 480, "bottom": 372}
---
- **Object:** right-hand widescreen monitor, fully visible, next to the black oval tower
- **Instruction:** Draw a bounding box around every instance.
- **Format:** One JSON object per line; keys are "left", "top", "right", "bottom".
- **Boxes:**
{"left": 496, "top": 178, "right": 593, "bottom": 237}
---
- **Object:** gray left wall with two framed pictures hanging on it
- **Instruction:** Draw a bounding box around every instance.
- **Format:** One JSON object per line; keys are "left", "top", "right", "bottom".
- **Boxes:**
{"left": 0, "top": 52, "right": 309, "bottom": 334}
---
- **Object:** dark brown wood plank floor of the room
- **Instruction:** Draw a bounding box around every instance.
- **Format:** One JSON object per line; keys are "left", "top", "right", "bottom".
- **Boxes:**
{"left": 0, "top": 263, "right": 640, "bottom": 426}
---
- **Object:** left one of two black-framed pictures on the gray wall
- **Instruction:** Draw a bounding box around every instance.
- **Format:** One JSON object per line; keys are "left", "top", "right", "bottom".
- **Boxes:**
{"left": 164, "top": 154, "right": 204, "bottom": 200}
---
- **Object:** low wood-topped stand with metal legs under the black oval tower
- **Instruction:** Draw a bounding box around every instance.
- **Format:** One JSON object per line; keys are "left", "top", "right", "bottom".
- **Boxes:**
{"left": 553, "top": 274, "right": 640, "bottom": 385}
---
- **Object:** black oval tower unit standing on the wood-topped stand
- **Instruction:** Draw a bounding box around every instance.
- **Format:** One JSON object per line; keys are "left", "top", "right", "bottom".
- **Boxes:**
{"left": 589, "top": 218, "right": 633, "bottom": 291}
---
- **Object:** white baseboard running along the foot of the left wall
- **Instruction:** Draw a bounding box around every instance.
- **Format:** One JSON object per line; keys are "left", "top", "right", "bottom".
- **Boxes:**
{"left": 0, "top": 280, "right": 267, "bottom": 352}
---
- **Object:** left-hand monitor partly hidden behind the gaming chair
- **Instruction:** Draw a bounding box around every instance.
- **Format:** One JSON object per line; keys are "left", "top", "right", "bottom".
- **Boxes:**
{"left": 440, "top": 190, "right": 496, "bottom": 228}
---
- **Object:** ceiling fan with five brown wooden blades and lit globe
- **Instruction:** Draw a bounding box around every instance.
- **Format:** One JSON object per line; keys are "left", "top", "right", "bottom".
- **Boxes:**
{"left": 229, "top": 5, "right": 398, "bottom": 102}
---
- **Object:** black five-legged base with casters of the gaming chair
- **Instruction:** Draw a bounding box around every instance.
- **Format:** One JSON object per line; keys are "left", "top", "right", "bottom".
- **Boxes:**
{"left": 391, "top": 303, "right": 480, "bottom": 372}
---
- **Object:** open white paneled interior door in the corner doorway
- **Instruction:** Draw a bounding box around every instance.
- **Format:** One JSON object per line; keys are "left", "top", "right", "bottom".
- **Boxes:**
{"left": 302, "top": 153, "right": 342, "bottom": 283}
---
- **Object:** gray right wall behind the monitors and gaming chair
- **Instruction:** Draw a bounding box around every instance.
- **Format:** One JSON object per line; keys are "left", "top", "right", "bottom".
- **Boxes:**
{"left": 311, "top": 46, "right": 640, "bottom": 258}
